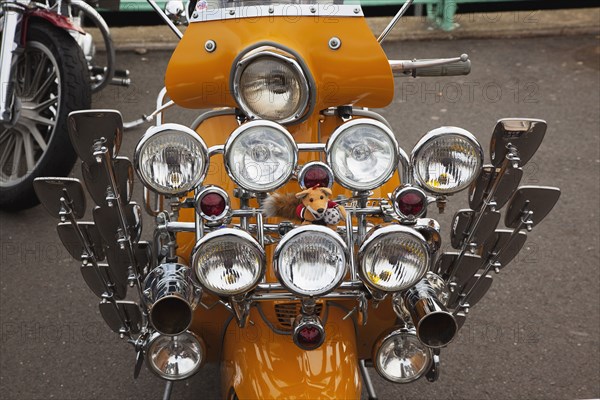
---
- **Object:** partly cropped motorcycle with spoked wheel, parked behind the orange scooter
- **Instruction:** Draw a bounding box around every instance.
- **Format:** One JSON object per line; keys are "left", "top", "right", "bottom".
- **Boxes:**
{"left": 0, "top": 0, "right": 129, "bottom": 211}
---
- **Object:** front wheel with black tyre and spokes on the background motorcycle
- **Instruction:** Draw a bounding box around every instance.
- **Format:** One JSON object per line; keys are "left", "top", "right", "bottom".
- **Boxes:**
{"left": 0, "top": 20, "right": 91, "bottom": 211}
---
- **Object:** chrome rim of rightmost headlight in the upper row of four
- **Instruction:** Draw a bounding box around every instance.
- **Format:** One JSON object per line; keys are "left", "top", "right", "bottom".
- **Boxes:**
{"left": 410, "top": 126, "right": 484, "bottom": 195}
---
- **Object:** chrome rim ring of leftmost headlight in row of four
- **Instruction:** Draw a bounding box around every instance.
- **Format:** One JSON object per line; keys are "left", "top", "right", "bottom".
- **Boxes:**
{"left": 133, "top": 123, "right": 210, "bottom": 198}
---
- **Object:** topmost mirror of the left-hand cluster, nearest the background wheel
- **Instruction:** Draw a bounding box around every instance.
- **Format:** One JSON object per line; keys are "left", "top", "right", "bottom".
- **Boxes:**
{"left": 68, "top": 110, "right": 123, "bottom": 165}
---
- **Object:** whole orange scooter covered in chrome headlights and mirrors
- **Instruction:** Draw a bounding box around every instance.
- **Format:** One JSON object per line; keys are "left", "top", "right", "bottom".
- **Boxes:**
{"left": 34, "top": 0, "right": 560, "bottom": 399}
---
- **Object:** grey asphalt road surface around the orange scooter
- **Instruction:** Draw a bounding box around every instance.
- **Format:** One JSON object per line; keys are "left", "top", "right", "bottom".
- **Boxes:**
{"left": 0, "top": 34, "right": 600, "bottom": 399}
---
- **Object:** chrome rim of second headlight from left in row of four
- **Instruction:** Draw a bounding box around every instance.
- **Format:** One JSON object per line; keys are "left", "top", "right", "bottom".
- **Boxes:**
{"left": 223, "top": 119, "right": 298, "bottom": 193}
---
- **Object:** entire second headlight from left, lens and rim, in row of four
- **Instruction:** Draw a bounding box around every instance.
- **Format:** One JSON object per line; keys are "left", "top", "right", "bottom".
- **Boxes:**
{"left": 225, "top": 121, "right": 298, "bottom": 192}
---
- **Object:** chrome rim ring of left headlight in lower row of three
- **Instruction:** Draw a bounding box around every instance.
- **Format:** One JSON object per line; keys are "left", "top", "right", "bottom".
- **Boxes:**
{"left": 190, "top": 228, "right": 266, "bottom": 297}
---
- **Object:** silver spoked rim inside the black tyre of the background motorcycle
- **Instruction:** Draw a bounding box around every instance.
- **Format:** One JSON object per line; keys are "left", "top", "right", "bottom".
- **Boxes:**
{"left": 0, "top": 42, "right": 61, "bottom": 187}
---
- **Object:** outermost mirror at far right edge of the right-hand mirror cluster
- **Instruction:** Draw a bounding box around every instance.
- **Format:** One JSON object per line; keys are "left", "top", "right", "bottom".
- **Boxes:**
{"left": 504, "top": 186, "right": 560, "bottom": 229}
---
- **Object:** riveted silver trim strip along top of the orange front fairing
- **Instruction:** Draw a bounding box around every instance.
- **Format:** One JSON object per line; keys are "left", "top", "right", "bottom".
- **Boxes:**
{"left": 190, "top": 4, "right": 364, "bottom": 24}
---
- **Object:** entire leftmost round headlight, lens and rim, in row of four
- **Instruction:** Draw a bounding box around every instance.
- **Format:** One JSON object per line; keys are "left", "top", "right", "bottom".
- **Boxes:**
{"left": 134, "top": 124, "right": 208, "bottom": 196}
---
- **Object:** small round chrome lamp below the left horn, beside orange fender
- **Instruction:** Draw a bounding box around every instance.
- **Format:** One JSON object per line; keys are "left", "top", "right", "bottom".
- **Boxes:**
{"left": 146, "top": 331, "right": 206, "bottom": 381}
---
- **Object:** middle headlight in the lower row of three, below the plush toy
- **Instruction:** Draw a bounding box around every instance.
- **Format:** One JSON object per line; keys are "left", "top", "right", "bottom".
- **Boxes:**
{"left": 273, "top": 225, "right": 348, "bottom": 296}
